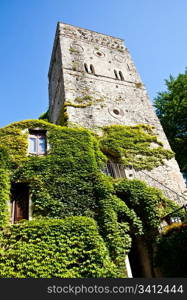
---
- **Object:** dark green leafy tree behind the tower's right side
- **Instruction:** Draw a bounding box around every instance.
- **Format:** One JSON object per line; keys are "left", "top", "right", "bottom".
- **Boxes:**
{"left": 154, "top": 70, "right": 187, "bottom": 174}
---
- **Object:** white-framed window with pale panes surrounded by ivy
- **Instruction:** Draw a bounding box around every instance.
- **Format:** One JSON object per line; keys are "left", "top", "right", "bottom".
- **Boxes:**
{"left": 29, "top": 130, "right": 47, "bottom": 155}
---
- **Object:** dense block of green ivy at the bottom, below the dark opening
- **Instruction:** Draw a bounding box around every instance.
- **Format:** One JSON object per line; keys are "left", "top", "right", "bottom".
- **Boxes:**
{"left": 0, "top": 217, "right": 118, "bottom": 278}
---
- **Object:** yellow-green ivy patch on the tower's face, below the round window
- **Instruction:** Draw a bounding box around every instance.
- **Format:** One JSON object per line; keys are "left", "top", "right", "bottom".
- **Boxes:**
{"left": 100, "top": 125, "right": 173, "bottom": 170}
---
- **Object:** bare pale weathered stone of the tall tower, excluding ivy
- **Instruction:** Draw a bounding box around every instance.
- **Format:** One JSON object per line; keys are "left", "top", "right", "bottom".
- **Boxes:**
{"left": 49, "top": 22, "right": 185, "bottom": 204}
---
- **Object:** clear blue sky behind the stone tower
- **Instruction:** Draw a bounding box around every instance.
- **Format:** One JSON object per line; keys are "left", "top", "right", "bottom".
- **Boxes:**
{"left": 0, "top": 0, "right": 187, "bottom": 127}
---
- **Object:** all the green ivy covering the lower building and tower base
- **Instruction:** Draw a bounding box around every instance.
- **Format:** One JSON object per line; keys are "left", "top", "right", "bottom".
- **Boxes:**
{"left": 0, "top": 118, "right": 181, "bottom": 278}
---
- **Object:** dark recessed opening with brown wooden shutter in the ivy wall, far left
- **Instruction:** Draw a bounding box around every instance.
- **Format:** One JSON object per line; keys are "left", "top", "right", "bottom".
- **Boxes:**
{"left": 11, "top": 183, "right": 29, "bottom": 224}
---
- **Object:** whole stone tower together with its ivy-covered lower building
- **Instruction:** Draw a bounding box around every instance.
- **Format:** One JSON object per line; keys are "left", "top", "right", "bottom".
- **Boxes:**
{"left": 0, "top": 23, "right": 187, "bottom": 278}
